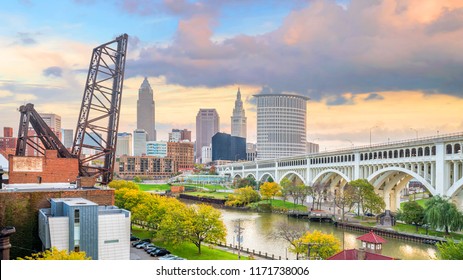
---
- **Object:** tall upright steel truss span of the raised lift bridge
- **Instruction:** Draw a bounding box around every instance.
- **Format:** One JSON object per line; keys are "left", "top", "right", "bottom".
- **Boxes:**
{"left": 72, "top": 34, "right": 128, "bottom": 185}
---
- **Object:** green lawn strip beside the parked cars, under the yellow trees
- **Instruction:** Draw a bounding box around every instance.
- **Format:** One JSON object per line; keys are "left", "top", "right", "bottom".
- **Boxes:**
{"left": 132, "top": 226, "right": 248, "bottom": 260}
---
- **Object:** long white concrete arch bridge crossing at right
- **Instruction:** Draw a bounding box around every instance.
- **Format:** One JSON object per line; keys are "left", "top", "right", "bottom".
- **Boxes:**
{"left": 217, "top": 132, "right": 463, "bottom": 211}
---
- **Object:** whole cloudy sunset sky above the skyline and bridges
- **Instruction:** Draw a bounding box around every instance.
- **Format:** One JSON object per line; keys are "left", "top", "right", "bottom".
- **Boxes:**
{"left": 0, "top": 0, "right": 463, "bottom": 150}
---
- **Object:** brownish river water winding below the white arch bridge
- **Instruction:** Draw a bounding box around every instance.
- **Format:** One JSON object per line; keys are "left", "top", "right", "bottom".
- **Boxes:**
{"left": 220, "top": 209, "right": 436, "bottom": 260}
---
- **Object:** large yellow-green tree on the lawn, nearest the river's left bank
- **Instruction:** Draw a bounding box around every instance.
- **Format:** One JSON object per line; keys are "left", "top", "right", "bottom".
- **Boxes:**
{"left": 184, "top": 204, "right": 227, "bottom": 254}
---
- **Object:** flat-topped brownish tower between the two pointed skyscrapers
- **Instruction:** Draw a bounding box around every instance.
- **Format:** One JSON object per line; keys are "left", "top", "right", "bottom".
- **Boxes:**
{"left": 196, "top": 109, "right": 220, "bottom": 162}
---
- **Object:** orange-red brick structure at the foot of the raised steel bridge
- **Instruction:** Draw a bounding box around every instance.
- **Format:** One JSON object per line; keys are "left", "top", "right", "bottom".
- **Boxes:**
{"left": 8, "top": 150, "right": 79, "bottom": 184}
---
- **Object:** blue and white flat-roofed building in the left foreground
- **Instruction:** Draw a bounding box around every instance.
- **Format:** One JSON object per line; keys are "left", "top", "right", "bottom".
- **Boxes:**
{"left": 39, "top": 198, "right": 130, "bottom": 260}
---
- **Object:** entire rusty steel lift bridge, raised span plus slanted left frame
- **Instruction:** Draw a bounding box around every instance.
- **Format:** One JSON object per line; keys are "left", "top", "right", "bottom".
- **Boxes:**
{"left": 16, "top": 34, "right": 128, "bottom": 185}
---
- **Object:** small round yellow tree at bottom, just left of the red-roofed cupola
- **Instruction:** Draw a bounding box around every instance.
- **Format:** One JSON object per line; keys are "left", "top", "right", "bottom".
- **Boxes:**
{"left": 297, "top": 230, "right": 341, "bottom": 260}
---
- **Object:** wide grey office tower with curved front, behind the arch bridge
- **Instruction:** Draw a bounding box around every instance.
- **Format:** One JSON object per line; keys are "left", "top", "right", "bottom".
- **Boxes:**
{"left": 254, "top": 93, "right": 309, "bottom": 159}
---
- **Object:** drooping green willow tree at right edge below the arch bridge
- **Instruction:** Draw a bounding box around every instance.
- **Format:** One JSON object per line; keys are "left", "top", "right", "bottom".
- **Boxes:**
{"left": 424, "top": 195, "right": 463, "bottom": 235}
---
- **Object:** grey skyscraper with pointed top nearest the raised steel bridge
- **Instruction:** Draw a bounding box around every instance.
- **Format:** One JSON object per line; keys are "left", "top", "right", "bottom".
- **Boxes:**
{"left": 137, "top": 77, "right": 156, "bottom": 141}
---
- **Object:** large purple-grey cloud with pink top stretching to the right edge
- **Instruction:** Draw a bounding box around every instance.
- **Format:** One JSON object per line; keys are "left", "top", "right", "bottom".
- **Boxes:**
{"left": 122, "top": 0, "right": 463, "bottom": 100}
